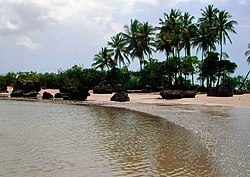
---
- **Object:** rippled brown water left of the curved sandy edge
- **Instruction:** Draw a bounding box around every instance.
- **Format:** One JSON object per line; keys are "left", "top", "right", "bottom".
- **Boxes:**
{"left": 0, "top": 101, "right": 216, "bottom": 177}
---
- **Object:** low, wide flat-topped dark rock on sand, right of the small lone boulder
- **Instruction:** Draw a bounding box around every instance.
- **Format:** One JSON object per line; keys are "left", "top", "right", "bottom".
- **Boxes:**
{"left": 160, "top": 90, "right": 196, "bottom": 99}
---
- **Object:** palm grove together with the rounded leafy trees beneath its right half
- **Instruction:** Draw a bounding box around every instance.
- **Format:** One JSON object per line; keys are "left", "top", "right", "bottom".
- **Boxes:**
{"left": 92, "top": 5, "right": 240, "bottom": 87}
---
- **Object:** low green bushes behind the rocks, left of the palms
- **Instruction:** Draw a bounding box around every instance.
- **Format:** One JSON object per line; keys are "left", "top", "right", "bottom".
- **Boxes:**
{"left": 0, "top": 65, "right": 106, "bottom": 89}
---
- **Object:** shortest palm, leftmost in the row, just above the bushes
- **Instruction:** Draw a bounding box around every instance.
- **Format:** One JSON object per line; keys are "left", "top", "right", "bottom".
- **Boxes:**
{"left": 92, "top": 47, "right": 116, "bottom": 71}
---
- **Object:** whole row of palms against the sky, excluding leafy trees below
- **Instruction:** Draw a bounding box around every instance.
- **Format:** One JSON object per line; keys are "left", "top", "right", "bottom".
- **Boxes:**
{"left": 92, "top": 5, "right": 237, "bottom": 85}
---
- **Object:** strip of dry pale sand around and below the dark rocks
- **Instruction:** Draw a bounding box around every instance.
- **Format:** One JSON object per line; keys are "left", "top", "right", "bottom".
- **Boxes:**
{"left": 0, "top": 87, "right": 250, "bottom": 108}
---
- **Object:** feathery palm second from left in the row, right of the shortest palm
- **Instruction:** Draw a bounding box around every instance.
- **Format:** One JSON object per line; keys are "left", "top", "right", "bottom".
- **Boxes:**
{"left": 108, "top": 33, "right": 130, "bottom": 68}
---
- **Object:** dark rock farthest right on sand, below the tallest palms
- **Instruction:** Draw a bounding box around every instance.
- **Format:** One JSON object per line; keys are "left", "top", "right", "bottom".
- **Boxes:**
{"left": 207, "top": 86, "right": 233, "bottom": 97}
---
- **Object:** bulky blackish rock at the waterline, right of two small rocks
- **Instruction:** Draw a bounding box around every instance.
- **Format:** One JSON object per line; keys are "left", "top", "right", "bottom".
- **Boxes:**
{"left": 60, "top": 86, "right": 90, "bottom": 101}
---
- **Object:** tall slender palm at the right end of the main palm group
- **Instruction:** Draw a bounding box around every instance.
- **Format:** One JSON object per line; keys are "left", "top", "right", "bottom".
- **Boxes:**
{"left": 216, "top": 10, "right": 237, "bottom": 60}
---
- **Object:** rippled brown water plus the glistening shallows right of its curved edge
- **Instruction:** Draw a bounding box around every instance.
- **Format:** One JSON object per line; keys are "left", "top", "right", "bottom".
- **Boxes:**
{"left": 0, "top": 100, "right": 250, "bottom": 176}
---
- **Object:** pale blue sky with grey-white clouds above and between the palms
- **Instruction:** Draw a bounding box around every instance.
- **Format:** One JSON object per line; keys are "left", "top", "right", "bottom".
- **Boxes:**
{"left": 0, "top": 0, "right": 250, "bottom": 75}
